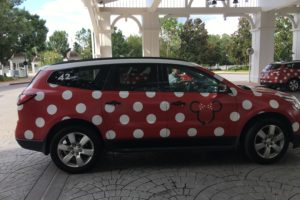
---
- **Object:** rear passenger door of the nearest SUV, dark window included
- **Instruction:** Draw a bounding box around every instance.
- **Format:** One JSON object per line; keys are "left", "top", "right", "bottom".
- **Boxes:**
{"left": 101, "top": 63, "right": 166, "bottom": 147}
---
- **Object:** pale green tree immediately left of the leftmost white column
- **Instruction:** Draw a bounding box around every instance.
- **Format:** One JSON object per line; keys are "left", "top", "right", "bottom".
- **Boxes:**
{"left": 73, "top": 28, "right": 92, "bottom": 59}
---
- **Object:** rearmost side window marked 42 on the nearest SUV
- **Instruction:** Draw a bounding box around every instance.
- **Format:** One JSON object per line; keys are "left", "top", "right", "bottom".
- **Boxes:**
{"left": 48, "top": 67, "right": 108, "bottom": 90}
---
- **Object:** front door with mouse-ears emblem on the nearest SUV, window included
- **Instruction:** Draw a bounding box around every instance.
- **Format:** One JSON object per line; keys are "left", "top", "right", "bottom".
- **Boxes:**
{"left": 160, "top": 64, "right": 240, "bottom": 145}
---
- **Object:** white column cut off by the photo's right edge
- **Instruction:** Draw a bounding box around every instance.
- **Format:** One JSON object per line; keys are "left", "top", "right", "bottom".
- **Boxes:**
{"left": 293, "top": 14, "right": 300, "bottom": 60}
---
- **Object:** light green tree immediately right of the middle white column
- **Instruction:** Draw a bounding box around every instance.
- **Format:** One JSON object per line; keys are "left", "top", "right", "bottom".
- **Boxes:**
{"left": 160, "top": 18, "right": 183, "bottom": 58}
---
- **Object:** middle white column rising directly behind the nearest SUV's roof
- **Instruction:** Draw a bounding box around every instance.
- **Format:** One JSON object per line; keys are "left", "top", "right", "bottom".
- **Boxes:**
{"left": 142, "top": 13, "right": 160, "bottom": 57}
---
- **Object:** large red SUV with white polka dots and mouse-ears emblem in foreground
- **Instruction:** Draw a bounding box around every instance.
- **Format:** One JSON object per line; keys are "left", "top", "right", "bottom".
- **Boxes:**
{"left": 16, "top": 58, "right": 300, "bottom": 173}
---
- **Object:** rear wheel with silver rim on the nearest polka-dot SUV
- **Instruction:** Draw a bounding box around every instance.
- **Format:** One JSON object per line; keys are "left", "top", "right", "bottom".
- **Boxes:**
{"left": 50, "top": 125, "right": 101, "bottom": 173}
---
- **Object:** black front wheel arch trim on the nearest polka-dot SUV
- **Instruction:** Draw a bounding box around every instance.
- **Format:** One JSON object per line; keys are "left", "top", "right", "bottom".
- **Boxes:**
{"left": 238, "top": 112, "right": 293, "bottom": 145}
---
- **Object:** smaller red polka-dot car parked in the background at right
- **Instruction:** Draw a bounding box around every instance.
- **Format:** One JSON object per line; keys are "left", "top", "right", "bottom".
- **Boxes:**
{"left": 260, "top": 61, "right": 300, "bottom": 92}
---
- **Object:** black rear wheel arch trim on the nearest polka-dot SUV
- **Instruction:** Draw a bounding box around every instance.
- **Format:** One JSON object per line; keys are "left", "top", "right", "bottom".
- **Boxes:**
{"left": 44, "top": 119, "right": 103, "bottom": 155}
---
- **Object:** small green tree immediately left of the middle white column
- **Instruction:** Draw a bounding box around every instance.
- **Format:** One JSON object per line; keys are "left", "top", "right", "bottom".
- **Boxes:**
{"left": 126, "top": 35, "right": 143, "bottom": 57}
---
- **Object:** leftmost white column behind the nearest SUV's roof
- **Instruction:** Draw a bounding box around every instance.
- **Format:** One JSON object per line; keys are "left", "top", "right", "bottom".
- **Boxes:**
{"left": 95, "top": 12, "right": 112, "bottom": 58}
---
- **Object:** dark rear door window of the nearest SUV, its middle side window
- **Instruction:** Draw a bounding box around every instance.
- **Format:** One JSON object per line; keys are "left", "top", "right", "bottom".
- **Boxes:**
{"left": 105, "top": 63, "right": 158, "bottom": 91}
